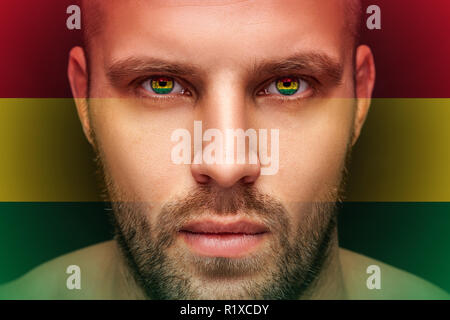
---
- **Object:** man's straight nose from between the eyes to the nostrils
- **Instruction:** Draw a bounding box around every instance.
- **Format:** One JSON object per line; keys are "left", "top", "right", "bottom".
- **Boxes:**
{"left": 191, "top": 72, "right": 260, "bottom": 188}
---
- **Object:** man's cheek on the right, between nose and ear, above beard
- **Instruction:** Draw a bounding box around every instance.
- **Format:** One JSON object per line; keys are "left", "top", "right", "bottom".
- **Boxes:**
{"left": 261, "top": 99, "right": 353, "bottom": 207}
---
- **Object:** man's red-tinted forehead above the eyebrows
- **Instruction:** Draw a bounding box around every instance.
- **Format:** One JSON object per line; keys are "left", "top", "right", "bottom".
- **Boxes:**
{"left": 91, "top": 0, "right": 351, "bottom": 68}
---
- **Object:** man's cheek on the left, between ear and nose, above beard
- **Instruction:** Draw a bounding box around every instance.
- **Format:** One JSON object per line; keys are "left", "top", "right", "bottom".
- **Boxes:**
{"left": 92, "top": 99, "right": 193, "bottom": 207}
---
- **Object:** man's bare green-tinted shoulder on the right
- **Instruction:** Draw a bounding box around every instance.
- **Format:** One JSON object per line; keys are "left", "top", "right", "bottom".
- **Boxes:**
{"left": 340, "top": 248, "right": 450, "bottom": 300}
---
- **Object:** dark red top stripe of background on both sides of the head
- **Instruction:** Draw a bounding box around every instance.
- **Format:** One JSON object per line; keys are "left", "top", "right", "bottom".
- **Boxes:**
{"left": 0, "top": 0, "right": 450, "bottom": 98}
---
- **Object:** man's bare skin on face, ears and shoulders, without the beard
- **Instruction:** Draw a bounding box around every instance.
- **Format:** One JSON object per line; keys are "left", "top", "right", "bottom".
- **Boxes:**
{"left": 0, "top": 0, "right": 444, "bottom": 299}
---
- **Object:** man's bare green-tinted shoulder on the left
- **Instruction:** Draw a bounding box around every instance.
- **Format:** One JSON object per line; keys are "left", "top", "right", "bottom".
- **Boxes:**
{"left": 0, "top": 241, "right": 117, "bottom": 300}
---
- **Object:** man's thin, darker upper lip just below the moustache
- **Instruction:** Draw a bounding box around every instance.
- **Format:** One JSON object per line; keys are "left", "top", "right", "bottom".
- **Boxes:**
{"left": 180, "top": 219, "right": 269, "bottom": 234}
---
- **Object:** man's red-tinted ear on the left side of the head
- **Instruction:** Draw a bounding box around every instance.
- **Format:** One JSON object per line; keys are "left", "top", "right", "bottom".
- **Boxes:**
{"left": 67, "top": 47, "right": 94, "bottom": 146}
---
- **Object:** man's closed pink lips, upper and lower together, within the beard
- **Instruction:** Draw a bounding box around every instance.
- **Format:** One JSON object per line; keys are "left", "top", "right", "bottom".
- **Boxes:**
{"left": 180, "top": 217, "right": 269, "bottom": 258}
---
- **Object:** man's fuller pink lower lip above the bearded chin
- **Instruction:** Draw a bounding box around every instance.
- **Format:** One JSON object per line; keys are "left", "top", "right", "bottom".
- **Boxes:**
{"left": 180, "top": 231, "right": 266, "bottom": 258}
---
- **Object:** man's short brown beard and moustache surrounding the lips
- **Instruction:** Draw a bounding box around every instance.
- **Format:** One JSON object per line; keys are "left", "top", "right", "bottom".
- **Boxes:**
{"left": 91, "top": 145, "right": 349, "bottom": 300}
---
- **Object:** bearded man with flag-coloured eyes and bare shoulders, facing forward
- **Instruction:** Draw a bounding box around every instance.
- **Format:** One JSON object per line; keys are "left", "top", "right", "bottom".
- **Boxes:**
{"left": 3, "top": 0, "right": 445, "bottom": 299}
